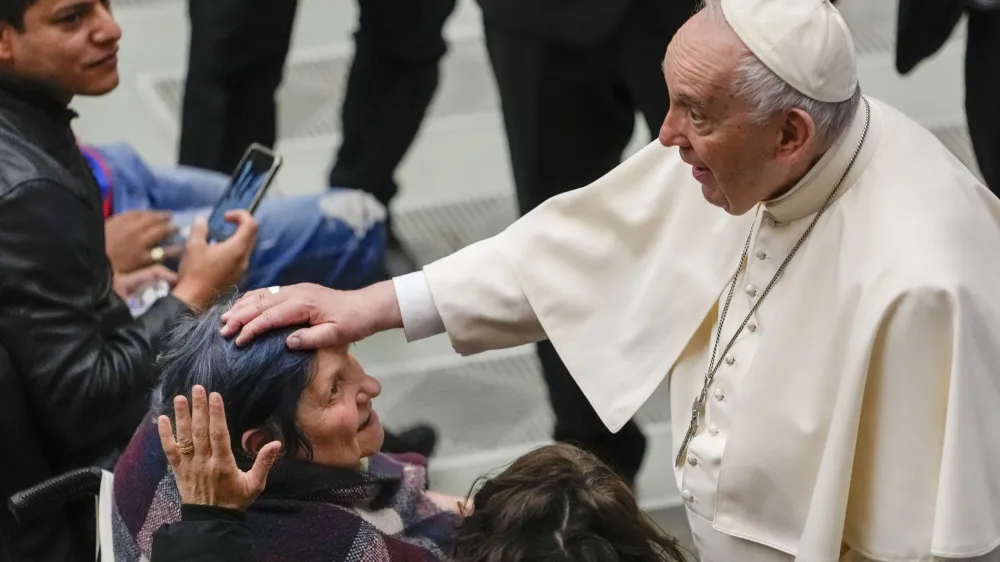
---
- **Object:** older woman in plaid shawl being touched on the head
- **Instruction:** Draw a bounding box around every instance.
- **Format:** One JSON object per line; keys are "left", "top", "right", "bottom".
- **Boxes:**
{"left": 114, "top": 304, "right": 460, "bottom": 562}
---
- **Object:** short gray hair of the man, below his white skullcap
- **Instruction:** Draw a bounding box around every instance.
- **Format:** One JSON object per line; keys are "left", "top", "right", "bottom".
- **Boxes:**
{"left": 701, "top": 0, "right": 861, "bottom": 144}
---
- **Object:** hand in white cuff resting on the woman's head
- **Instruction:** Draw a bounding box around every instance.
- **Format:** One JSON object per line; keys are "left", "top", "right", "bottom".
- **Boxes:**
{"left": 222, "top": 281, "right": 403, "bottom": 349}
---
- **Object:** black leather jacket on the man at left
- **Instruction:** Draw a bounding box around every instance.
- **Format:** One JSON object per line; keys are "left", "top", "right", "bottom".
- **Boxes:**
{"left": 0, "top": 80, "right": 186, "bottom": 473}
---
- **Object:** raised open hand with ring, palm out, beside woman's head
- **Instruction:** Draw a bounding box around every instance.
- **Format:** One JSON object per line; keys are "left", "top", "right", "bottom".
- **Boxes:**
{"left": 157, "top": 386, "right": 281, "bottom": 511}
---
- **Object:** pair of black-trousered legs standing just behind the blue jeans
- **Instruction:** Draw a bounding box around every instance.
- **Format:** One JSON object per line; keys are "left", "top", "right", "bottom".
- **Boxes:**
{"left": 180, "top": 0, "right": 455, "bottom": 277}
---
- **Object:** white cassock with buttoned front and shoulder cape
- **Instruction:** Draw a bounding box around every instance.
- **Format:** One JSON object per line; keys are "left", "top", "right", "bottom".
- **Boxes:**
{"left": 395, "top": 99, "right": 1000, "bottom": 562}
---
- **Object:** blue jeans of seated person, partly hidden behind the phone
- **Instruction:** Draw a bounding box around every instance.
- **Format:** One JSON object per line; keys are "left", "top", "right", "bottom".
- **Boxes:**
{"left": 95, "top": 144, "right": 386, "bottom": 290}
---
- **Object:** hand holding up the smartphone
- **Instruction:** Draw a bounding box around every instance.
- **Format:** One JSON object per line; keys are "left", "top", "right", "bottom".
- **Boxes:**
{"left": 174, "top": 211, "right": 257, "bottom": 309}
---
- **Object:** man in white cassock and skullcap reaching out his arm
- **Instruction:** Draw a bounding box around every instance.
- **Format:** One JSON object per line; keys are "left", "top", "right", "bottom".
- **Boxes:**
{"left": 223, "top": 0, "right": 1000, "bottom": 562}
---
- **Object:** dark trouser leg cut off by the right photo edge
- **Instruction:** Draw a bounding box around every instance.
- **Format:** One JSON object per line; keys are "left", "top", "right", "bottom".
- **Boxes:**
{"left": 965, "top": 10, "right": 1000, "bottom": 191}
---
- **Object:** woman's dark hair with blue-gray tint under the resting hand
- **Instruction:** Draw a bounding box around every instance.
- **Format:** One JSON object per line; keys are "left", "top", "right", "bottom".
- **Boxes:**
{"left": 154, "top": 297, "right": 315, "bottom": 459}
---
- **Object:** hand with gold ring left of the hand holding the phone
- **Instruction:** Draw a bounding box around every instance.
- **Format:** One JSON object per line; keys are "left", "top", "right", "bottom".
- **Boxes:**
{"left": 104, "top": 211, "right": 182, "bottom": 273}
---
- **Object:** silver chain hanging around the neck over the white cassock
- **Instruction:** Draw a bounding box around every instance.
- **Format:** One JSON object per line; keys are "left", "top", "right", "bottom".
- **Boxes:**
{"left": 674, "top": 98, "right": 871, "bottom": 467}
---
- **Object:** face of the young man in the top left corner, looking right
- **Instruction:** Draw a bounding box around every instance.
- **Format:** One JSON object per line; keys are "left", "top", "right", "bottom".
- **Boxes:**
{"left": 0, "top": 0, "right": 121, "bottom": 101}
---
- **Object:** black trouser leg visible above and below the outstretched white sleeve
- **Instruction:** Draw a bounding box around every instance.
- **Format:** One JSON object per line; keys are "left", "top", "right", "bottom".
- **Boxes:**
{"left": 485, "top": 20, "right": 655, "bottom": 482}
